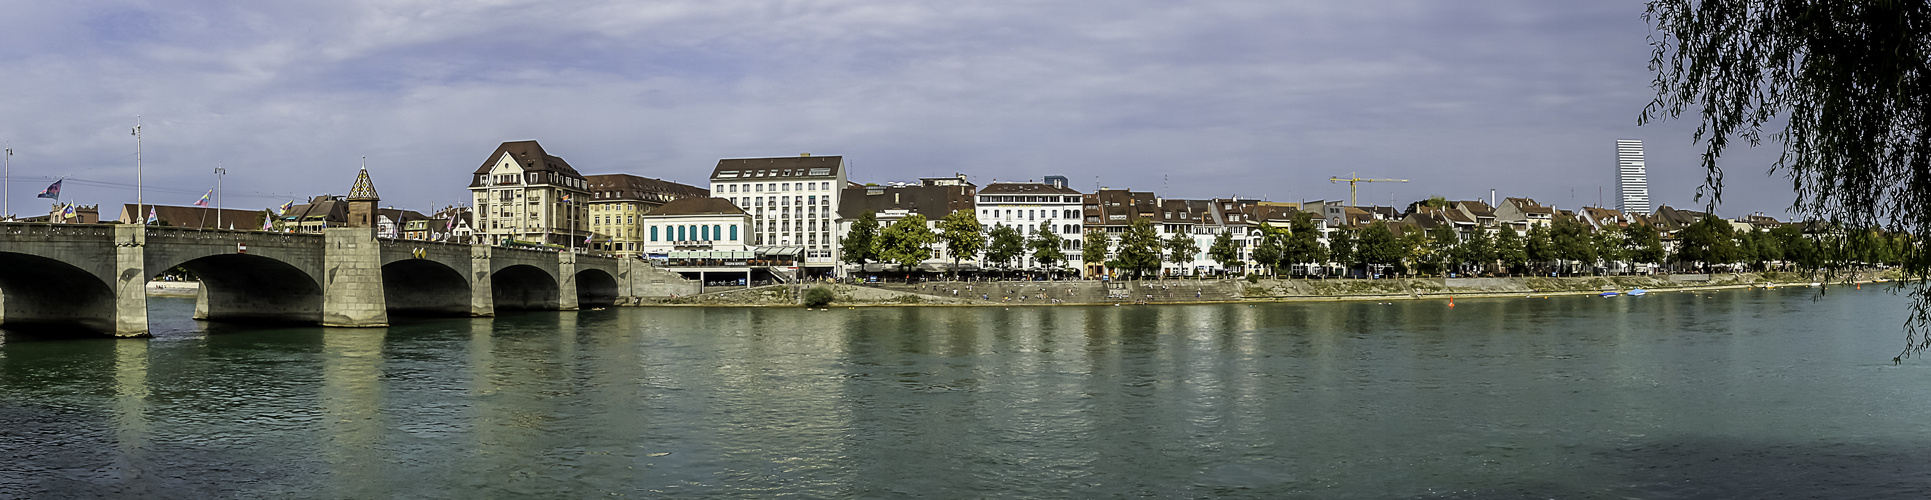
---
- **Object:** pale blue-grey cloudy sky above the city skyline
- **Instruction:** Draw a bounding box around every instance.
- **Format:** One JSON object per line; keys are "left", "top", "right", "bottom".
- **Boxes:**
{"left": 0, "top": 0, "right": 1792, "bottom": 216}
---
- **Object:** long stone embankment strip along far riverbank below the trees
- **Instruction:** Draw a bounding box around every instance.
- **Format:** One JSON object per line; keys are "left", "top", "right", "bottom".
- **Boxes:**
{"left": 637, "top": 270, "right": 1900, "bottom": 307}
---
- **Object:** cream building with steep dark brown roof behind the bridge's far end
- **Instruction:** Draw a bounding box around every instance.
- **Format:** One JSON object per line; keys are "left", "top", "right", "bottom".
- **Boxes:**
{"left": 469, "top": 141, "right": 589, "bottom": 245}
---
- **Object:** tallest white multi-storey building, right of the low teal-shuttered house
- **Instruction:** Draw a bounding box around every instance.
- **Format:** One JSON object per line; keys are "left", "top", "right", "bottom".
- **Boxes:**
{"left": 711, "top": 154, "right": 848, "bottom": 276}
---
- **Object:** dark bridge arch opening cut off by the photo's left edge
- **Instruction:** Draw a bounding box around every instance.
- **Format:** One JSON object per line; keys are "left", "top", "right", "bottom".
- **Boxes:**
{"left": 0, "top": 251, "right": 116, "bottom": 334}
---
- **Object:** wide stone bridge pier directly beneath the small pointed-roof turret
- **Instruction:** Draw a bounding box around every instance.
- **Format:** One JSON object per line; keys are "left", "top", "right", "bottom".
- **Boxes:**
{"left": 320, "top": 228, "right": 388, "bottom": 328}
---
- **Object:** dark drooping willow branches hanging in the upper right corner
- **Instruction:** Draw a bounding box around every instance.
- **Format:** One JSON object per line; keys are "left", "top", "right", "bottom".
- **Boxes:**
{"left": 1639, "top": 0, "right": 1931, "bottom": 359}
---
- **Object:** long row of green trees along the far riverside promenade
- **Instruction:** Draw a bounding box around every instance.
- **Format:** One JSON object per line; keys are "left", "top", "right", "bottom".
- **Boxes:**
{"left": 840, "top": 210, "right": 1916, "bottom": 276}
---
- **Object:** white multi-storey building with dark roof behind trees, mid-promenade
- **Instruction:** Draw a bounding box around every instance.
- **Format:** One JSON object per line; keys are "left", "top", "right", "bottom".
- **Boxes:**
{"left": 973, "top": 178, "right": 1085, "bottom": 268}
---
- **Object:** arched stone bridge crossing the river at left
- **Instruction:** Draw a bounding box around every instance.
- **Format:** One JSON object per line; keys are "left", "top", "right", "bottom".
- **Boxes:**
{"left": 0, "top": 224, "right": 695, "bottom": 336}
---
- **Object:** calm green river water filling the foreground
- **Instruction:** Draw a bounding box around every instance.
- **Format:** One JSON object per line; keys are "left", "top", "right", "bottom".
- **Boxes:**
{"left": 0, "top": 290, "right": 1931, "bottom": 498}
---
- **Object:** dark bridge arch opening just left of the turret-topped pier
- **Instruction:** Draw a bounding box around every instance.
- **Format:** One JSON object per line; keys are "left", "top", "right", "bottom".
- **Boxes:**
{"left": 160, "top": 253, "right": 322, "bottom": 322}
